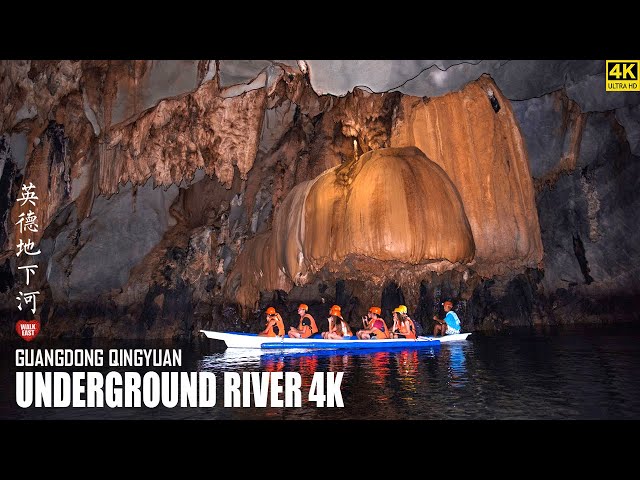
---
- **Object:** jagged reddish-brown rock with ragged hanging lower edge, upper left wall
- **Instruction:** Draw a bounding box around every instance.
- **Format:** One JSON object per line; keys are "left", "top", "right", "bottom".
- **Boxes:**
{"left": 99, "top": 82, "right": 266, "bottom": 194}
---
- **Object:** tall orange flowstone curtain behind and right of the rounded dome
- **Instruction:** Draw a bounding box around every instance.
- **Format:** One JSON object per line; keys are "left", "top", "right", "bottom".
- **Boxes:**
{"left": 391, "top": 77, "right": 543, "bottom": 276}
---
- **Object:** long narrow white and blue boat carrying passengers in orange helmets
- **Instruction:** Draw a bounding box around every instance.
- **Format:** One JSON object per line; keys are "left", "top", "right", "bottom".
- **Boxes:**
{"left": 200, "top": 330, "right": 471, "bottom": 349}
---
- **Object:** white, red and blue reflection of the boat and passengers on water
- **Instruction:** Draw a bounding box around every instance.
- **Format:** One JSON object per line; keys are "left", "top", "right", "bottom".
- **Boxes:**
{"left": 199, "top": 344, "right": 467, "bottom": 418}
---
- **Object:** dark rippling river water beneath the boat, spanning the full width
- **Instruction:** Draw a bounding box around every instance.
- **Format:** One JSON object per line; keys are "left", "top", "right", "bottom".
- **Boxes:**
{"left": 0, "top": 326, "right": 640, "bottom": 420}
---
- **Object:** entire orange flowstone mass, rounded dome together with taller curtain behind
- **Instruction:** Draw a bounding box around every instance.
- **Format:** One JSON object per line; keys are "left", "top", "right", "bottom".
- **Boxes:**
{"left": 226, "top": 77, "right": 543, "bottom": 305}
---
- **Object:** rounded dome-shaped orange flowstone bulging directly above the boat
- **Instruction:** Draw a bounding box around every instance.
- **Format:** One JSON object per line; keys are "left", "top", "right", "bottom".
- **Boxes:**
{"left": 227, "top": 147, "right": 475, "bottom": 305}
